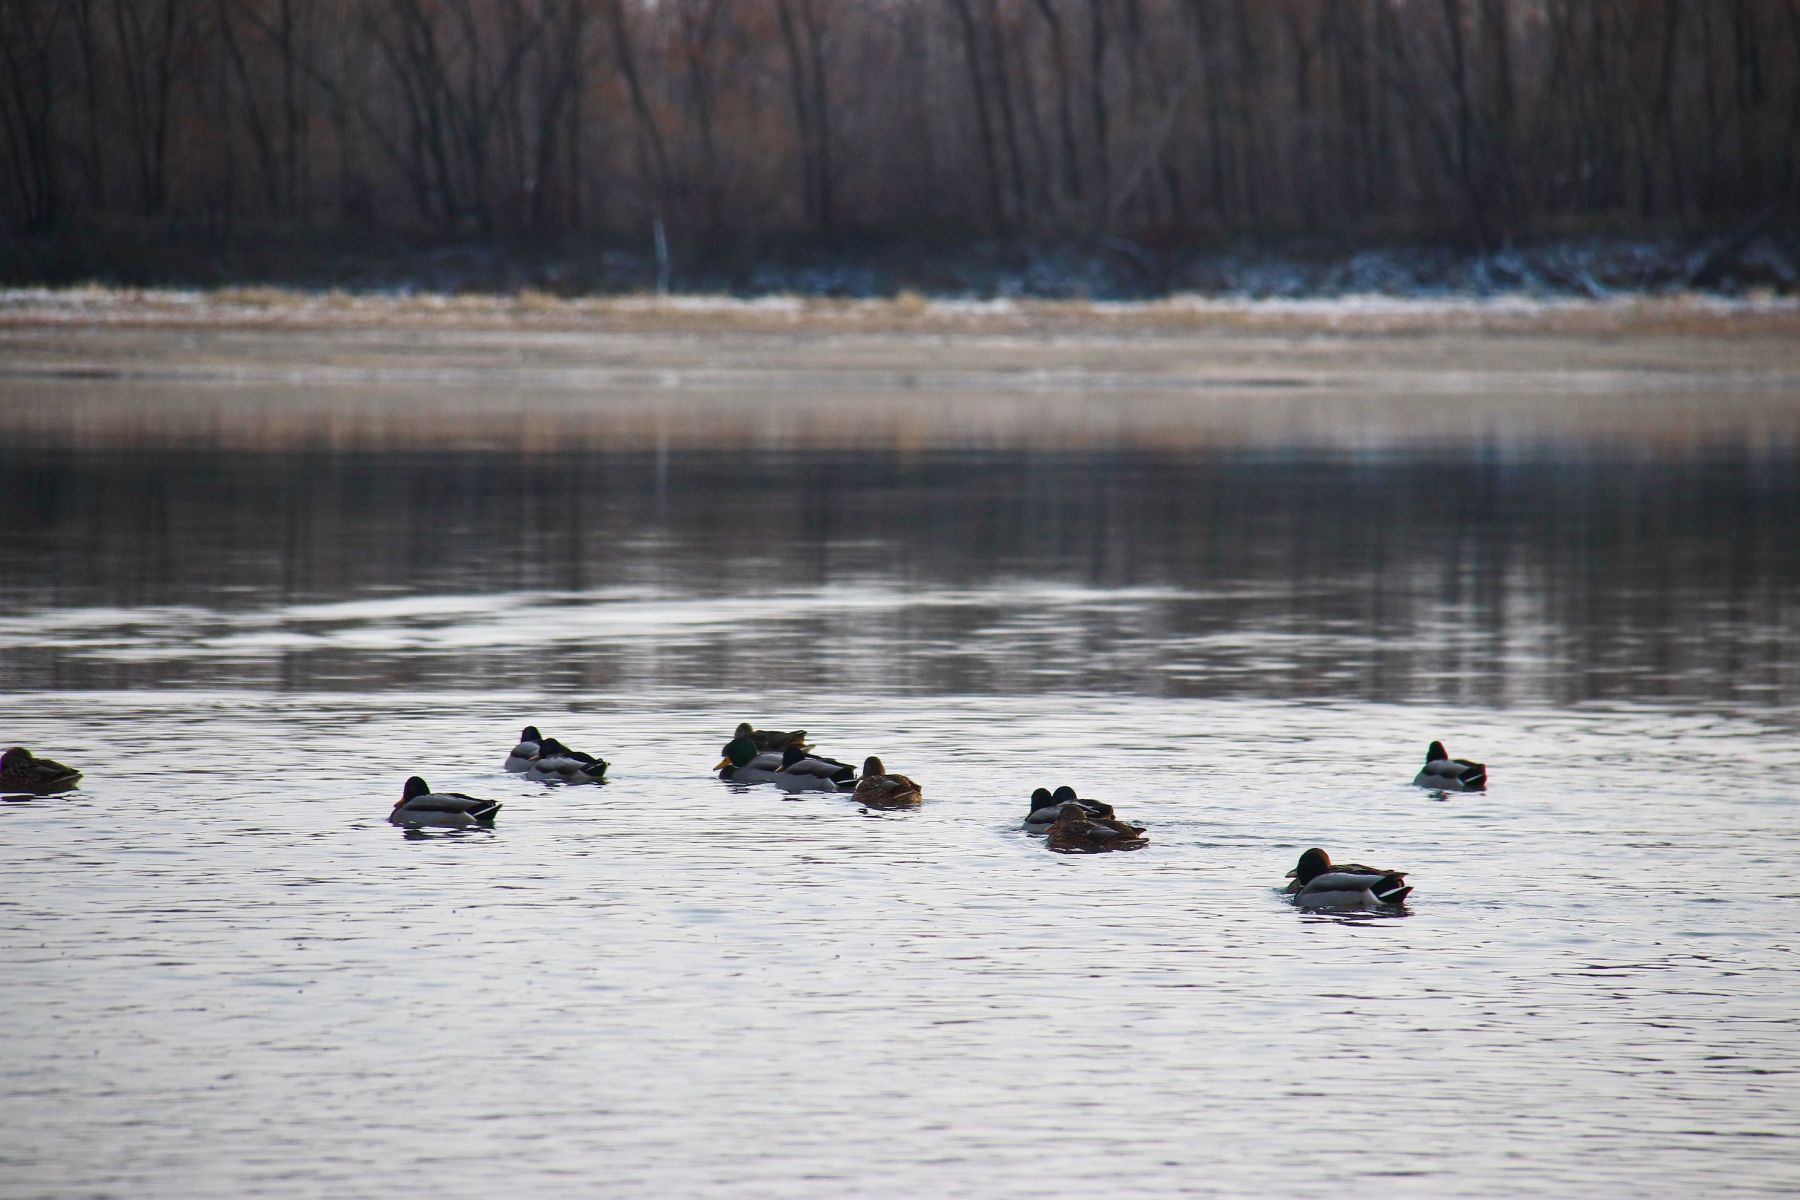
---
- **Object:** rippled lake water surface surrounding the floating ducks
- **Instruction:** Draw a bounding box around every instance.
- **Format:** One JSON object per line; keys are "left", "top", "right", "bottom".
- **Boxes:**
{"left": 0, "top": 313, "right": 1800, "bottom": 1198}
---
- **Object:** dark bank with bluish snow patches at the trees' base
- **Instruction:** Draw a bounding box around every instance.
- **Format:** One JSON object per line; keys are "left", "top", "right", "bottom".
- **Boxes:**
{"left": 0, "top": 227, "right": 1800, "bottom": 302}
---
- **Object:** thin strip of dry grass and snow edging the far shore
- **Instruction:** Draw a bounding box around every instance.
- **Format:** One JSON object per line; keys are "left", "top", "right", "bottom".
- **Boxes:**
{"left": 0, "top": 286, "right": 1800, "bottom": 340}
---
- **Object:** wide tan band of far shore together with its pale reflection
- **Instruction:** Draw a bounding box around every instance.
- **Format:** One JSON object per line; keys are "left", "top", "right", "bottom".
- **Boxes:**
{"left": 0, "top": 290, "right": 1800, "bottom": 453}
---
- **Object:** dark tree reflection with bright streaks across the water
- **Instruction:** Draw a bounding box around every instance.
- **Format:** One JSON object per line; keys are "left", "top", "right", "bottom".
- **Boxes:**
{"left": 0, "top": 444, "right": 1800, "bottom": 705}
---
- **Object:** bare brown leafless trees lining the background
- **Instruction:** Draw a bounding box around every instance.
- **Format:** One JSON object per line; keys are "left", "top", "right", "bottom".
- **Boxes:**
{"left": 0, "top": 0, "right": 1800, "bottom": 246}
